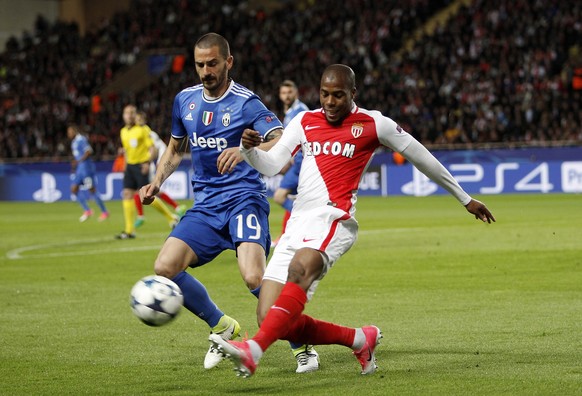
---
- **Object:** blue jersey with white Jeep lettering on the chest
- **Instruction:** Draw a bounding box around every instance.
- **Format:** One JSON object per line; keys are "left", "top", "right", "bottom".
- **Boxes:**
{"left": 172, "top": 81, "right": 282, "bottom": 210}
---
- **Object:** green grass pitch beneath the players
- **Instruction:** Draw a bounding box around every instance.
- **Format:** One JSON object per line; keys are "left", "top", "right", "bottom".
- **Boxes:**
{"left": 0, "top": 194, "right": 582, "bottom": 395}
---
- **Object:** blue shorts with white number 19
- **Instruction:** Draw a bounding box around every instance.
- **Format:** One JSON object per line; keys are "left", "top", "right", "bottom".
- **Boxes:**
{"left": 170, "top": 197, "right": 271, "bottom": 267}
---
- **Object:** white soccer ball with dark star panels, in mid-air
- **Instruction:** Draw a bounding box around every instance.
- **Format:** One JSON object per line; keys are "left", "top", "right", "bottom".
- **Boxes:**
{"left": 129, "top": 275, "right": 184, "bottom": 326}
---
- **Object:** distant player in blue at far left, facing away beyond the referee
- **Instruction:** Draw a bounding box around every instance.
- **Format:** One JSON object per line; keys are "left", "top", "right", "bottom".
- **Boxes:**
{"left": 67, "top": 124, "right": 109, "bottom": 222}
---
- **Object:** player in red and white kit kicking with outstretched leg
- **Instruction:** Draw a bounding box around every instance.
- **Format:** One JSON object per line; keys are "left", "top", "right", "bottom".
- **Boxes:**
{"left": 210, "top": 64, "right": 495, "bottom": 377}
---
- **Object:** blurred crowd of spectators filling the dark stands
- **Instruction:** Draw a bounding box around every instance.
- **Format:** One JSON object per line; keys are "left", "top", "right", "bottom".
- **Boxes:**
{"left": 0, "top": 0, "right": 582, "bottom": 159}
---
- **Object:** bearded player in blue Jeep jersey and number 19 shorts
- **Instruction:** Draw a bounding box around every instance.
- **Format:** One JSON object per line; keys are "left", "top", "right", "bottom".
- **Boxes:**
{"left": 139, "top": 33, "right": 318, "bottom": 369}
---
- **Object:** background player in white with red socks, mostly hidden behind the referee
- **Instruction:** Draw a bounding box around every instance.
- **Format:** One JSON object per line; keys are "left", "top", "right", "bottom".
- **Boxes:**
{"left": 134, "top": 110, "right": 187, "bottom": 228}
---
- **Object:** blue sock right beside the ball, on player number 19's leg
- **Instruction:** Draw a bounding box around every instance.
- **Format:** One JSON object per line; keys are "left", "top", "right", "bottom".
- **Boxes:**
{"left": 172, "top": 271, "right": 224, "bottom": 328}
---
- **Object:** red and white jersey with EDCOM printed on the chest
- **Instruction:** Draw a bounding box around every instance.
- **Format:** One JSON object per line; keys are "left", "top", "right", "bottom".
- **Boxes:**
{"left": 279, "top": 105, "right": 413, "bottom": 215}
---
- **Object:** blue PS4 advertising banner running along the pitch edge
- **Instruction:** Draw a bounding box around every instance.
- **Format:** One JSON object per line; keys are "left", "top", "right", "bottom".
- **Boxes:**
{"left": 0, "top": 147, "right": 582, "bottom": 202}
